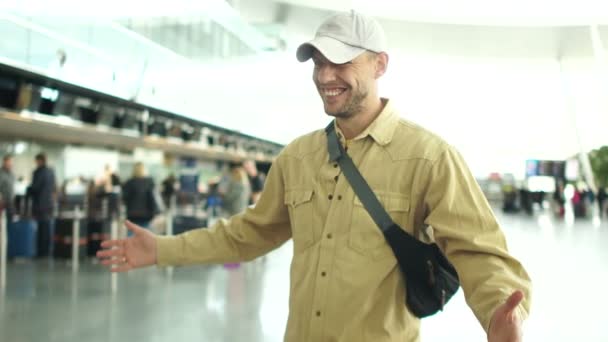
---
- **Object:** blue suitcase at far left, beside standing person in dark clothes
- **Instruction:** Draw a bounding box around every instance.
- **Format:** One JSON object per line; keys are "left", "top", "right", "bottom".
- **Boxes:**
{"left": 7, "top": 219, "right": 38, "bottom": 258}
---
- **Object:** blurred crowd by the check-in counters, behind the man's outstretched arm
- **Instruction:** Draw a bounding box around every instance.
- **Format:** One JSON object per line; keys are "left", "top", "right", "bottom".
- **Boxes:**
{"left": 0, "top": 153, "right": 264, "bottom": 257}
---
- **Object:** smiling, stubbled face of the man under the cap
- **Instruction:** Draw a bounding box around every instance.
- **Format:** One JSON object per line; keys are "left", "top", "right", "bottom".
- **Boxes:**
{"left": 312, "top": 51, "right": 376, "bottom": 118}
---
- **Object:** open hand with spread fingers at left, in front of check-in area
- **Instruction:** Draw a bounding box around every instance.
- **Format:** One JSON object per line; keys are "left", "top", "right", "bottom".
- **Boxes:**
{"left": 97, "top": 221, "right": 156, "bottom": 272}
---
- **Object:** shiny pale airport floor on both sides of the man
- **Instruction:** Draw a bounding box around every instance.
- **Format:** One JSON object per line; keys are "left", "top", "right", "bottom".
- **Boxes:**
{"left": 0, "top": 207, "right": 608, "bottom": 342}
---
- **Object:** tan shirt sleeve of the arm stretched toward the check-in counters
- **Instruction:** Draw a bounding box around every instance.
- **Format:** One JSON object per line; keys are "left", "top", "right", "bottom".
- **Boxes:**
{"left": 156, "top": 156, "right": 291, "bottom": 266}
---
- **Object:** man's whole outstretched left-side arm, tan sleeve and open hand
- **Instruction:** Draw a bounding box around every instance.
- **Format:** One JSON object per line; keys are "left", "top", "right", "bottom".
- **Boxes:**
{"left": 97, "top": 159, "right": 291, "bottom": 272}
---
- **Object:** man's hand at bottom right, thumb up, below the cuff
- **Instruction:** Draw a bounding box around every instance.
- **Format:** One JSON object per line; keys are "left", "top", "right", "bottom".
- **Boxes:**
{"left": 488, "top": 290, "right": 524, "bottom": 342}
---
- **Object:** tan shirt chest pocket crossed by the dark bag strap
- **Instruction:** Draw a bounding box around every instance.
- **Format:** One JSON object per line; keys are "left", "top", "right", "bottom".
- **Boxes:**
{"left": 348, "top": 192, "right": 410, "bottom": 259}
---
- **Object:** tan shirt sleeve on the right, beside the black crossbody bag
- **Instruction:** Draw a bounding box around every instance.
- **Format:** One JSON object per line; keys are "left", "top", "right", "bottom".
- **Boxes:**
{"left": 424, "top": 147, "right": 531, "bottom": 332}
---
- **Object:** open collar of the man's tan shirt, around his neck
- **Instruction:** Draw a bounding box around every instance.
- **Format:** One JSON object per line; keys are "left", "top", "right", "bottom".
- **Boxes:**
{"left": 334, "top": 98, "right": 399, "bottom": 146}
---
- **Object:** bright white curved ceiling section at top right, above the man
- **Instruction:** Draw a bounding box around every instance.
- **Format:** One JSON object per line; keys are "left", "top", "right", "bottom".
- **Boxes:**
{"left": 276, "top": 0, "right": 608, "bottom": 26}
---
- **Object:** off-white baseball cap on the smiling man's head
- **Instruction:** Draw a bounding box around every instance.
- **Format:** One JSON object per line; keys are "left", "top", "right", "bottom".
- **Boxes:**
{"left": 296, "top": 11, "right": 386, "bottom": 64}
